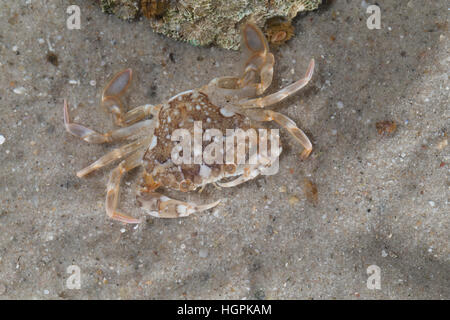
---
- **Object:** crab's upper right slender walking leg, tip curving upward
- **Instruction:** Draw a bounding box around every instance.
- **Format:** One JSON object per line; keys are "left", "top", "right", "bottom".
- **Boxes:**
{"left": 239, "top": 59, "right": 315, "bottom": 108}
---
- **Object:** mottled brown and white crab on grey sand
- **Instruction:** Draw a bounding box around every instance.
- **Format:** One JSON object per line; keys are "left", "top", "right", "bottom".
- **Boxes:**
{"left": 64, "top": 23, "right": 314, "bottom": 224}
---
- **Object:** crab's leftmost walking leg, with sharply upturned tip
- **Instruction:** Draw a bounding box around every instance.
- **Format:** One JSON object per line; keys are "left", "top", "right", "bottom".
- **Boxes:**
{"left": 64, "top": 100, "right": 153, "bottom": 143}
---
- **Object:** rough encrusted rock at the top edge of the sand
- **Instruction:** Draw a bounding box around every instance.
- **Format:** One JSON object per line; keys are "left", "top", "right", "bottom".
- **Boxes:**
{"left": 101, "top": 0, "right": 322, "bottom": 49}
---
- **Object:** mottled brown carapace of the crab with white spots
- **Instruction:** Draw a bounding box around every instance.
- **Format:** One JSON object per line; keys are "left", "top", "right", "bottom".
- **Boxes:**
{"left": 143, "top": 90, "right": 252, "bottom": 191}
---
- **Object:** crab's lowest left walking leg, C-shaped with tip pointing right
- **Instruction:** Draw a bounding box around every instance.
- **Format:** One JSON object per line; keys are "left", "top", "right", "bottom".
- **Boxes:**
{"left": 105, "top": 152, "right": 142, "bottom": 223}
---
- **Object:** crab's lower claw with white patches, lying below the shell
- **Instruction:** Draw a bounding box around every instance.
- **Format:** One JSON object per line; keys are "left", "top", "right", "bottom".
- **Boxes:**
{"left": 137, "top": 192, "right": 220, "bottom": 218}
